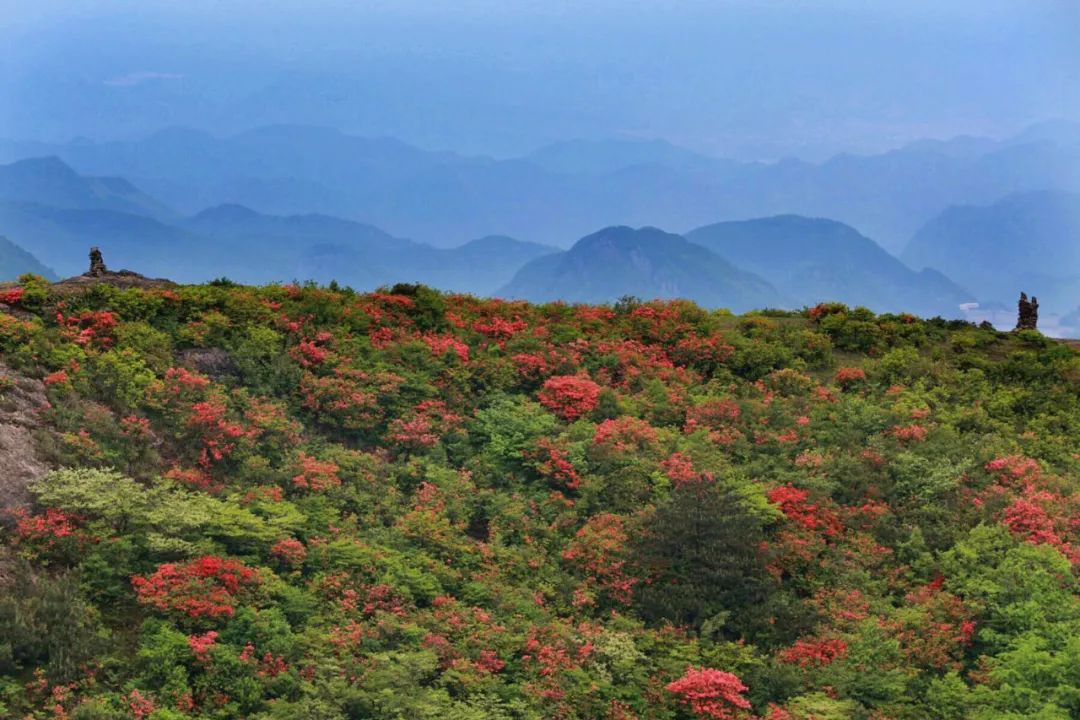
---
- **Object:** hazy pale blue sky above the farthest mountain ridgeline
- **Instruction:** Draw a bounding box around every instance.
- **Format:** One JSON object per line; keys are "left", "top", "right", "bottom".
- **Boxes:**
{"left": 0, "top": 0, "right": 1080, "bottom": 159}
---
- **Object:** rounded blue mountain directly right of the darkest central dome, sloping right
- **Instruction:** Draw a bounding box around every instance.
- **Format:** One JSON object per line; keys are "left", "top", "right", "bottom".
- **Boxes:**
{"left": 686, "top": 215, "right": 973, "bottom": 316}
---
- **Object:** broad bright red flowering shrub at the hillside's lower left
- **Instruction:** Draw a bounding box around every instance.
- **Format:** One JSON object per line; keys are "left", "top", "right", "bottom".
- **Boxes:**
{"left": 132, "top": 555, "right": 258, "bottom": 617}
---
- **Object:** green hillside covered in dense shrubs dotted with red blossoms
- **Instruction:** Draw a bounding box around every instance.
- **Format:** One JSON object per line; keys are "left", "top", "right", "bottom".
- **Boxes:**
{"left": 0, "top": 279, "right": 1080, "bottom": 720}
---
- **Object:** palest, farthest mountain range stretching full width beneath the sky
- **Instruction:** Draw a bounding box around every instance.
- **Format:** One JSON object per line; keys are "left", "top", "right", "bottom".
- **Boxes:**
{"left": 0, "top": 124, "right": 1080, "bottom": 253}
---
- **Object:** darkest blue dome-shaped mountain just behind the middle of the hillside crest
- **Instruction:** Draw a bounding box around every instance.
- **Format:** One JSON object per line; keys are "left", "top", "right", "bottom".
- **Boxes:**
{"left": 499, "top": 227, "right": 780, "bottom": 311}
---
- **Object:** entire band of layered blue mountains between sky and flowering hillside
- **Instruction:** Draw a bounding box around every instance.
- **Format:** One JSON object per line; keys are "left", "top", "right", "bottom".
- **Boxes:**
{"left": 0, "top": 123, "right": 1080, "bottom": 329}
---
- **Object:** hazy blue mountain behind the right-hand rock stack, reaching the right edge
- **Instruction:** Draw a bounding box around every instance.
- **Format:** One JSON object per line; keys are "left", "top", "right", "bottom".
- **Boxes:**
{"left": 901, "top": 191, "right": 1080, "bottom": 312}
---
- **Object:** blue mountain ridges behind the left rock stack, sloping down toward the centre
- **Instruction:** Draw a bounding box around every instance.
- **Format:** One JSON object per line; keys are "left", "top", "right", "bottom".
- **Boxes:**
{"left": 0, "top": 158, "right": 555, "bottom": 294}
